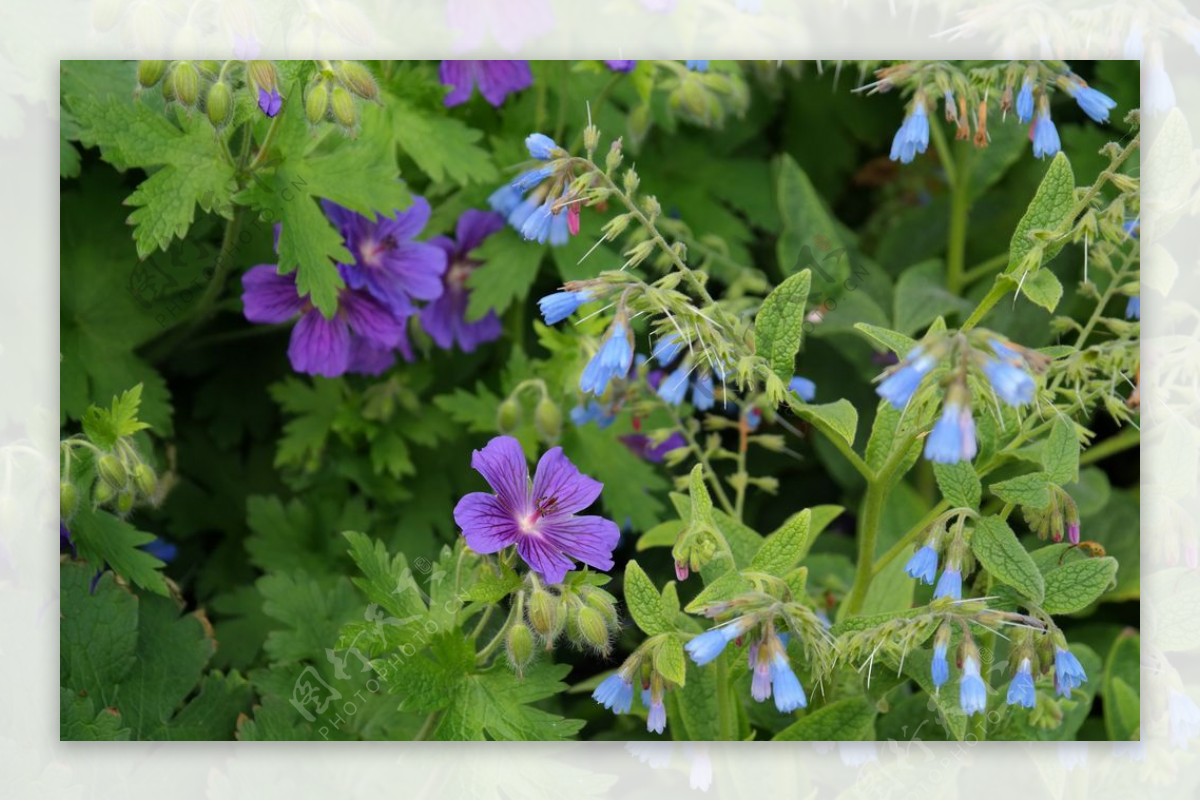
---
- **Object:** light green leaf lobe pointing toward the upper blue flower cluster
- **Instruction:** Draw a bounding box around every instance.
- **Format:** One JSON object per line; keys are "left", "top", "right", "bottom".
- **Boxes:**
{"left": 384, "top": 95, "right": 498, "bottom": 183}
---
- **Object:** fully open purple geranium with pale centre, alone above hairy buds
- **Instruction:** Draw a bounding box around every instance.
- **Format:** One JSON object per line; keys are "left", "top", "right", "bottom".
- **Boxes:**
{"left": 454, "top": 436, "right": 620, "bottom": 584}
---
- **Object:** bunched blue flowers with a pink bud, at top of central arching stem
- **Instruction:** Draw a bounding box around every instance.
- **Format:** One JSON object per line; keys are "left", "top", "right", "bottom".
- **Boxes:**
{"left": 487, "top": 133, "right": 580, "bottom": 246}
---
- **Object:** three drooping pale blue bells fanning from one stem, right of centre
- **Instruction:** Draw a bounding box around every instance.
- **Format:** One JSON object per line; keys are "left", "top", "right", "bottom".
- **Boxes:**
{"left": 875, "top": 336, "right": 1037, "bottom": 464}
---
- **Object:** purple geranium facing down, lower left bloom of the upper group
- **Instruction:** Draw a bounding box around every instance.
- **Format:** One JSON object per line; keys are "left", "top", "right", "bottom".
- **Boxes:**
{"left": 241, "top": 264, "right": 410, "bottom": 378}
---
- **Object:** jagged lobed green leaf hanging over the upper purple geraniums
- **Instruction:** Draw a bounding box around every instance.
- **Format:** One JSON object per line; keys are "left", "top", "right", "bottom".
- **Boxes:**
{"left": 236, "top": 97, "right": 410, "bottom": 317}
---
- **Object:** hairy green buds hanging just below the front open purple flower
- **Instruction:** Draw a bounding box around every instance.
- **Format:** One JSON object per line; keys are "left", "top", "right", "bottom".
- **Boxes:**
{"left": 504, "top": 572, "right": 620, "bottom": 674}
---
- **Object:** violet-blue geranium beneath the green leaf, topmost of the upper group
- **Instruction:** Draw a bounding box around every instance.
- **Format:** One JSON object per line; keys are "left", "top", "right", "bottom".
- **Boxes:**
{"left": 322, "top": 197, "right": 446, "bottom": 318}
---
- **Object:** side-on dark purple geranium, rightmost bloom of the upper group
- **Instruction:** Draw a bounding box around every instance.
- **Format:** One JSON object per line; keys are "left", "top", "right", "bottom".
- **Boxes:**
{"left": 421, "top": 209, "right": 504, "bottom": 354}
